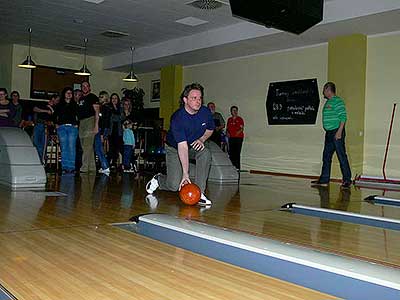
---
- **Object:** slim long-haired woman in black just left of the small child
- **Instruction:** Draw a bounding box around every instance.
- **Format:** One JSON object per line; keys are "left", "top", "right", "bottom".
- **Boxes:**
{"left": 109, "top": 93, "right": 122, "bottom": 168}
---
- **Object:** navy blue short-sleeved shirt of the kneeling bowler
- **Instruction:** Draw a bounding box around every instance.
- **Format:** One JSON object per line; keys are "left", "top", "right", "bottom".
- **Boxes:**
{"left": 167, "top": 106, "right": 215, "bottom": 148}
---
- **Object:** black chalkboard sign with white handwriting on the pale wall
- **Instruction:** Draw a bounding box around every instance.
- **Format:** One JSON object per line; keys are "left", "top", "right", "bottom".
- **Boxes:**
{"left": 266, "top": 78, "right": 319, "bottom": 125}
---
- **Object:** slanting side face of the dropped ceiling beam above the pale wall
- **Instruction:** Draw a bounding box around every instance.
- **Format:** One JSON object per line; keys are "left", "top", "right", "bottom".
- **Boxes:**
{"left": 112, "top": 10, "right": 400, "bottom": 73}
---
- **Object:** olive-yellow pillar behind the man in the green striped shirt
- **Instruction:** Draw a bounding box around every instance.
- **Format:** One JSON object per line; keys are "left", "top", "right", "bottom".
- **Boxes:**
{"left": 328, "top": 34, "right": 367, "bottom": 178}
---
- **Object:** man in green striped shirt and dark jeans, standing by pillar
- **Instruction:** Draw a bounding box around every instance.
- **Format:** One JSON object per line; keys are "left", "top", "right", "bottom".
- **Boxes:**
{"left": 311, "top": 82, "right": 351, "bottom": 188}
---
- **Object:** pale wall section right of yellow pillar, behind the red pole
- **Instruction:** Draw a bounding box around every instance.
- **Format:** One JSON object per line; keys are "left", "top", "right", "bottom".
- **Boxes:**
{"left": 364, "top": 34, "right": 400, "bottom": 178}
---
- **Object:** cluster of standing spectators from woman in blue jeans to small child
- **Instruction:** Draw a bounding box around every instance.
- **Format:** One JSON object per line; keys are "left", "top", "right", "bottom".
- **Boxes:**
{"left": 54, "top": 82, "right": 135, "bottom": 175}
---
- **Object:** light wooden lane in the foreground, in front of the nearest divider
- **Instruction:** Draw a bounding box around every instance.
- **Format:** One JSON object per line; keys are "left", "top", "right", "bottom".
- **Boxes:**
{"left": 0, "top": 225, "right": 333, "bottom": 300}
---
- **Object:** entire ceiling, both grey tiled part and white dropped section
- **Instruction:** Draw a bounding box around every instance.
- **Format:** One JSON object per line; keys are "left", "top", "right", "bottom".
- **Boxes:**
{"left": 0, "top": 0, "right": 400, "bottom": 73}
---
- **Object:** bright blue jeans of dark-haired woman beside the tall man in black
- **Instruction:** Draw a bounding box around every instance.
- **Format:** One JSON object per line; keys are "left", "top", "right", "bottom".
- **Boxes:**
{"left": 57, "top": 125, "right": 78, "bottom": 171}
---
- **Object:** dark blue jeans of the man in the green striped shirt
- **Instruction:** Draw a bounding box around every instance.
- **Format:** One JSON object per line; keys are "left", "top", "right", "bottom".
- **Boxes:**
{"left": 319, "top": 129, "right": 351, "bottom": 183}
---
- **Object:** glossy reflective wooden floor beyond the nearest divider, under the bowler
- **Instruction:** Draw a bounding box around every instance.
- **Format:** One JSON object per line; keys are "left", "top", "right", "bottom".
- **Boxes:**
{"left": 0, "top": 174, "right": 400, "bottom": 266}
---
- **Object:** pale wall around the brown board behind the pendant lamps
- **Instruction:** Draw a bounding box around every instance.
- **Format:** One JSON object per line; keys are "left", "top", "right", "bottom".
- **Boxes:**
{"left": 11, "top": 45, "right": 132, "bottom": 99}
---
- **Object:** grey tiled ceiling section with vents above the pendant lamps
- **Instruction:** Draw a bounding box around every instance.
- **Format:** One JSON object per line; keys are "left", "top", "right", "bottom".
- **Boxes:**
{"left": 0, "top": 0, "right": 240, "bottom": 56}
